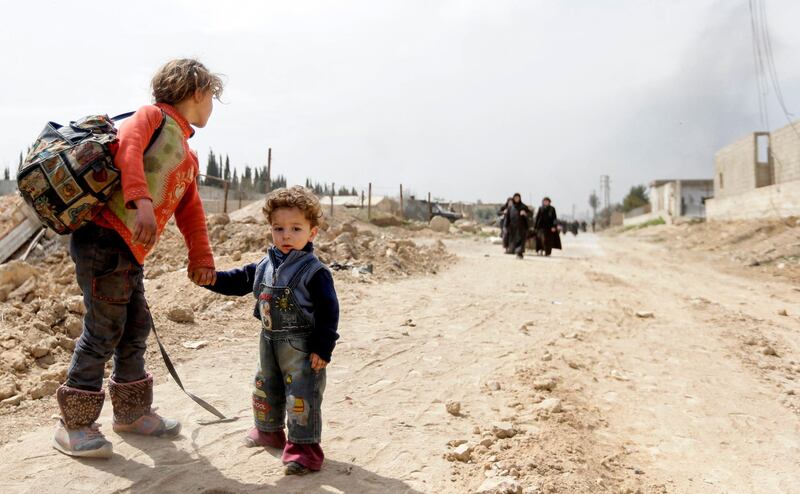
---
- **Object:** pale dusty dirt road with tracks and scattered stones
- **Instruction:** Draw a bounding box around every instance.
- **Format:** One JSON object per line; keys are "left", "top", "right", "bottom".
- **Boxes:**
{"left": 0, "top": 235, "right": 800, "bottom": 494}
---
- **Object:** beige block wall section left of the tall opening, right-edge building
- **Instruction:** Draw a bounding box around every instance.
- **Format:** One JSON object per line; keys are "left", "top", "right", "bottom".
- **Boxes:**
{"left": 714, "top": 134, "right": 756, "bottom": 198}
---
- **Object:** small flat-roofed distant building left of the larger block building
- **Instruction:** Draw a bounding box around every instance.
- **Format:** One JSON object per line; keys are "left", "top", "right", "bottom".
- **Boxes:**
{"left": 623, "top": 179, "right": 714, "bottom": 226}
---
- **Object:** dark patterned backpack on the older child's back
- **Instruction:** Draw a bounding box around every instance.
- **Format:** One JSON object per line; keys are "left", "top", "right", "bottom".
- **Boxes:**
{"left": 17, "top": 112, "right": 164, "bottom": 235}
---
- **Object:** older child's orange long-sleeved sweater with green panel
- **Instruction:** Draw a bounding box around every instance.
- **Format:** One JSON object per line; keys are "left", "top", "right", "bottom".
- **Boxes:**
{"left": 94, "top": 103, "right": 214, "bottom": 270}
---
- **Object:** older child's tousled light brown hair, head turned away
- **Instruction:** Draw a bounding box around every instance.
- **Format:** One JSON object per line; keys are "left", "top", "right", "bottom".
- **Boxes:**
{"left": 150, "top": 58, "right": 224, "bottom": 105}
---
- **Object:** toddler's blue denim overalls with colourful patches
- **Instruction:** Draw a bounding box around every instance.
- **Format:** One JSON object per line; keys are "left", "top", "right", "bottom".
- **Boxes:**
{"left": 253, "top": 250, "right": 325, "bottom": 444}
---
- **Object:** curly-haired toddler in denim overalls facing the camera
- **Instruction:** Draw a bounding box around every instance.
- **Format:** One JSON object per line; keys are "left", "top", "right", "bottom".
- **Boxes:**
{"left": 206, "top": 187, "right": 339, "bottom": 475}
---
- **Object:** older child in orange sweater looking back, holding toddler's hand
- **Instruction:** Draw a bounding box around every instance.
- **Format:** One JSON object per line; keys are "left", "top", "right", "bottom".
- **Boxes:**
{"left": 53, "top": 59, "right": 222, "bottom": 458}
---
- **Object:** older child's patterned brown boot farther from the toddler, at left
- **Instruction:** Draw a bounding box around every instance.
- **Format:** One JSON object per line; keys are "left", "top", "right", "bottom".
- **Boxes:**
{"left": 53, "top": 385, "right": 114, "bottom": 458}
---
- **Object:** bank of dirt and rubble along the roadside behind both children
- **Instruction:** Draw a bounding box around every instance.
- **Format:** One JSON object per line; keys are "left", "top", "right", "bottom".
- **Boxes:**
{"left": 0, "top": 204, "right": 453, "bottom": 408}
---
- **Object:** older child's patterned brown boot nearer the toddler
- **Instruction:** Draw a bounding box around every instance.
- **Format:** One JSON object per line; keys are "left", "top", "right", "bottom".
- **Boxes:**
{"left": 108, "top": 374, "right": 181, "bottom": 437}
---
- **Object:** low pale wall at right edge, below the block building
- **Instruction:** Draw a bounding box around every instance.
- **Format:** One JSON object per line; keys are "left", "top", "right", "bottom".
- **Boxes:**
{"left": 706, "top": 180, "right": 800, "bottom": 221}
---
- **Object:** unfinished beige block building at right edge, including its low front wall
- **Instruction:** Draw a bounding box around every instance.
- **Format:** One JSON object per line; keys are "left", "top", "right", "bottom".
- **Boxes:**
{"left": 706, "top": 122, "right": 800, "bottom": 220}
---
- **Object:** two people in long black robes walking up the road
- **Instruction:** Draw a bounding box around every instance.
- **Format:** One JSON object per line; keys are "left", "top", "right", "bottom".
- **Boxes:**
{"left": 499, "top": 193, "right": 561, "bottom": 259}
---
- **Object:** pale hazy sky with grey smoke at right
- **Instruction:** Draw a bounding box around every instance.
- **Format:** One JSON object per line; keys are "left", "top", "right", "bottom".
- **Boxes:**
{"left": 0, "top": 0, "right": 800, "bottom": 214}
